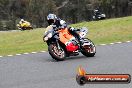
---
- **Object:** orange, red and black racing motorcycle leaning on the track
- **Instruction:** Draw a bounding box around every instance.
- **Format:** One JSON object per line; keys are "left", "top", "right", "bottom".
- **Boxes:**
{"left": 43, "top": 26, "right": 96, "bottom": 61}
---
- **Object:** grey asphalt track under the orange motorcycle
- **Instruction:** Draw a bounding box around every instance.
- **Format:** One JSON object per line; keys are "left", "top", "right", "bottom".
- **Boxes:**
{"left": 0, "top": 42, "right": 132, "bottom": 88}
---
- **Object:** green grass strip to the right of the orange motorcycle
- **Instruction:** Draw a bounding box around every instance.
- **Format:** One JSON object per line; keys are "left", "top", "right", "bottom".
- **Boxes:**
{"left": 72, "top": 16, "right": 132, "bottom": 44}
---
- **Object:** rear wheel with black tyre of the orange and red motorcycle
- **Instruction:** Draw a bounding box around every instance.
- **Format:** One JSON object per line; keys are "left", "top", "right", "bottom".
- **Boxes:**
{"left": 81, "top": 39, "right": 96, "bottom": 57}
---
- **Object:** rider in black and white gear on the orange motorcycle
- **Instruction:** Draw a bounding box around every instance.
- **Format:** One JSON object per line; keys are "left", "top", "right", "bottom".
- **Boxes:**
{"left": 47, "top": 14, "right": 82, "bottom": 42}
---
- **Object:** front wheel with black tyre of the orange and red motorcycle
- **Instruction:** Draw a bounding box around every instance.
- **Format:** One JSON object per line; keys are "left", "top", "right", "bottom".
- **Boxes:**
{"left": 48, "top": 44, "right": 66, "bottom": 61}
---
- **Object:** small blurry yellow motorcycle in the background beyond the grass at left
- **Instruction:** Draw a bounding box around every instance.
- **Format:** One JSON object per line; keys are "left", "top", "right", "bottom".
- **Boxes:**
{"left": 17, "top": 22, "right": 33, "bottom": 31}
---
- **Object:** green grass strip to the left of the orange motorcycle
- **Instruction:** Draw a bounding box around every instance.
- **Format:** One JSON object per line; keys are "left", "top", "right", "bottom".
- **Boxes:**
{"left": 0, "top": 29, "right": 46, "bottom": 55}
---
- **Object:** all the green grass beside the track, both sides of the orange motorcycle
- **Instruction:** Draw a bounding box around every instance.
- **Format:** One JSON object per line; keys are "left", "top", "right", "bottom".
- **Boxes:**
{"left": 0, "top": 17, "right": 132, "bottom": 55}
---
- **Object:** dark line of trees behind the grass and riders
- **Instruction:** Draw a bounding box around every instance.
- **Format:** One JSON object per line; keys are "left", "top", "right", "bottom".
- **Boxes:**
{"left": 0, "top": 0, "right": 132, "bottom": 30}
